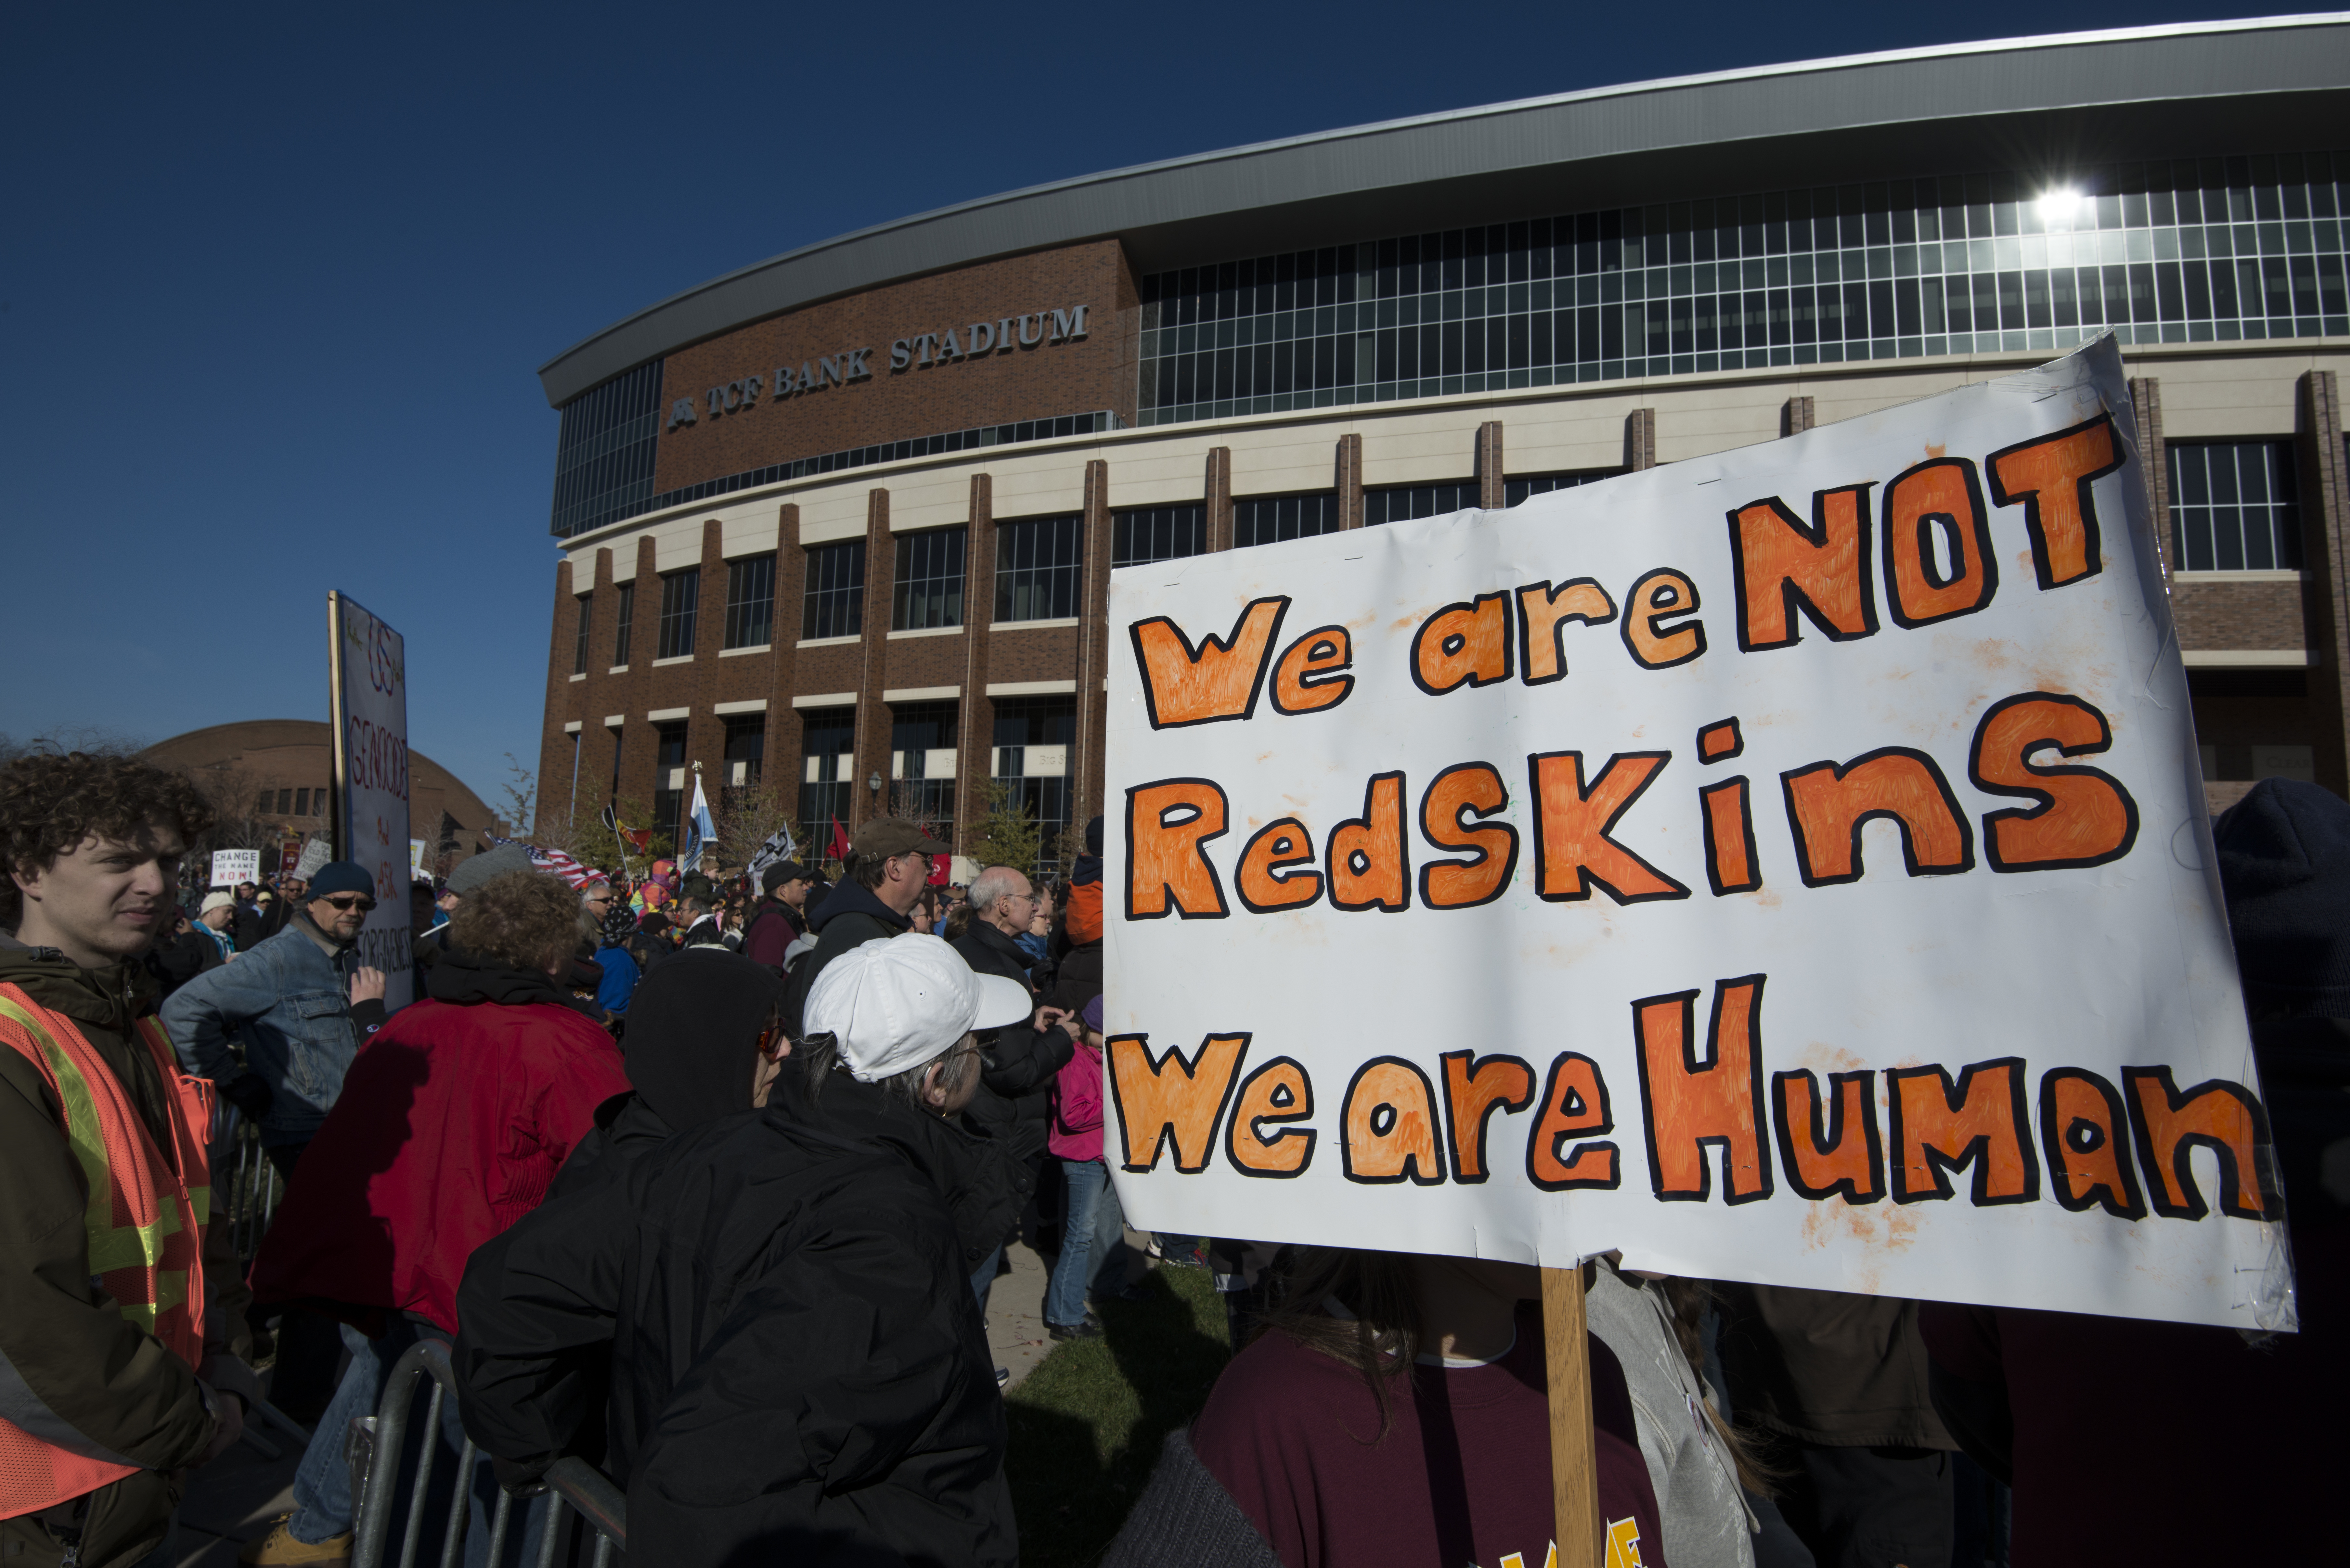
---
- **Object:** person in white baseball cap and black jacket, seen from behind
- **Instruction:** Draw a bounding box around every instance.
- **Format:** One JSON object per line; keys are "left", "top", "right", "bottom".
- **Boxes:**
{"left": 456, "top": 936, "right": 1029, "bottom": 1568}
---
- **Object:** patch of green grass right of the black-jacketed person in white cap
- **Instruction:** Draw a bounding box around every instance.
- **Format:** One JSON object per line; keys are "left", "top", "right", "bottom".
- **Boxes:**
{"left": 1003, "top": 1269, "right": 1232, "bottom": 1568}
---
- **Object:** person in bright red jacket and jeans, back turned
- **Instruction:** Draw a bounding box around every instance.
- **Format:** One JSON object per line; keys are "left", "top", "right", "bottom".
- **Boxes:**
{"left": 240, "top": 872, "right": 630, "bottom": 1563}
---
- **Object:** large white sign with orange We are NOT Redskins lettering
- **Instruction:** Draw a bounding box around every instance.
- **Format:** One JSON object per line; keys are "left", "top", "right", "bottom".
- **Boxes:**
{"left": 1104, "top": 341, "right": 2291, "bottom": 1326}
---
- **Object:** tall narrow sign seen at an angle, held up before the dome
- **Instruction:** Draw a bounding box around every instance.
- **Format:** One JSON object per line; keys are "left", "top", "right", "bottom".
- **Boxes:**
{"left": 327, "top": 595, "right": 414, "bottom": 1009}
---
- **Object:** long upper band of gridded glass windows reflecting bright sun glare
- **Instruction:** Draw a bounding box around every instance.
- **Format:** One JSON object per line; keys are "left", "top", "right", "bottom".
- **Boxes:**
{"left": 1137, "top": 153, "right": 2350, "bottom": 426}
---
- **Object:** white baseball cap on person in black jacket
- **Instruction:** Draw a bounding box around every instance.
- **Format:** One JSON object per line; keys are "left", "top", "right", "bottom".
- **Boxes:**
{"left": 801, "top": 931, "right": 1032, "bottom": 1084}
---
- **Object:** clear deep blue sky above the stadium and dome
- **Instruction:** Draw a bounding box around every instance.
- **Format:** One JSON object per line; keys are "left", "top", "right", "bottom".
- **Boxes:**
{"left": 0, "top": 0, "right": 2263, "bottom": 823}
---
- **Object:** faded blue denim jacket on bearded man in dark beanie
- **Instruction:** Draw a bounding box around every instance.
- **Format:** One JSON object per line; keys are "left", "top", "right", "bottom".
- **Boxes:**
{"left": 162, "top": 915, "right": 359, "bottom": 1147}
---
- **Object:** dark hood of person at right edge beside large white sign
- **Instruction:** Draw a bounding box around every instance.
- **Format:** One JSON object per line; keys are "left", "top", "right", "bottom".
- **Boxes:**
{"left": 2211, "top": 778, "right": 2350, "bottom": 1018}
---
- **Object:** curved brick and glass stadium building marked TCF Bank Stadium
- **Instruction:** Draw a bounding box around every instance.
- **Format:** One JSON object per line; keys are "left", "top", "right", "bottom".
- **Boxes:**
{"left": 540, "top": 17, "right": 2350, "bottom": 865}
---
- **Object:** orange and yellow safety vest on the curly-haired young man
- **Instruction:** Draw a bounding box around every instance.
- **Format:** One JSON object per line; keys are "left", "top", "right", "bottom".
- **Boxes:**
{"left": 0, "top": 985, "right": 214, "bottom": 1519}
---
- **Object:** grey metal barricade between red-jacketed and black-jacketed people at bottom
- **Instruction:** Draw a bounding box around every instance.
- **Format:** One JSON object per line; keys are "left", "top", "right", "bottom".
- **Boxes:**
{"left": 345, "top": 1340, "right": 627, "bottom": 1568}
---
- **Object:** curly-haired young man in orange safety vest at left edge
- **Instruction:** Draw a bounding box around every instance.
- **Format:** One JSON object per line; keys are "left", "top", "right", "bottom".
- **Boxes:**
{"left": 0, "top": 752, "right": 256, "bottom": 1568}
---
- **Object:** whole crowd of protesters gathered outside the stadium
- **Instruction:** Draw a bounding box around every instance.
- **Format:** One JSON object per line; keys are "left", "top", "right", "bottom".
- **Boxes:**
{"left": 0, "top": 755, "right": 2350, "bottom": 1568}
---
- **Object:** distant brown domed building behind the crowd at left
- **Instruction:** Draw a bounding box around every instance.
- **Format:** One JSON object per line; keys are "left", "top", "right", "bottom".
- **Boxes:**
{"left": 141, "top": 719, "right": 503, "bottom": 875}
